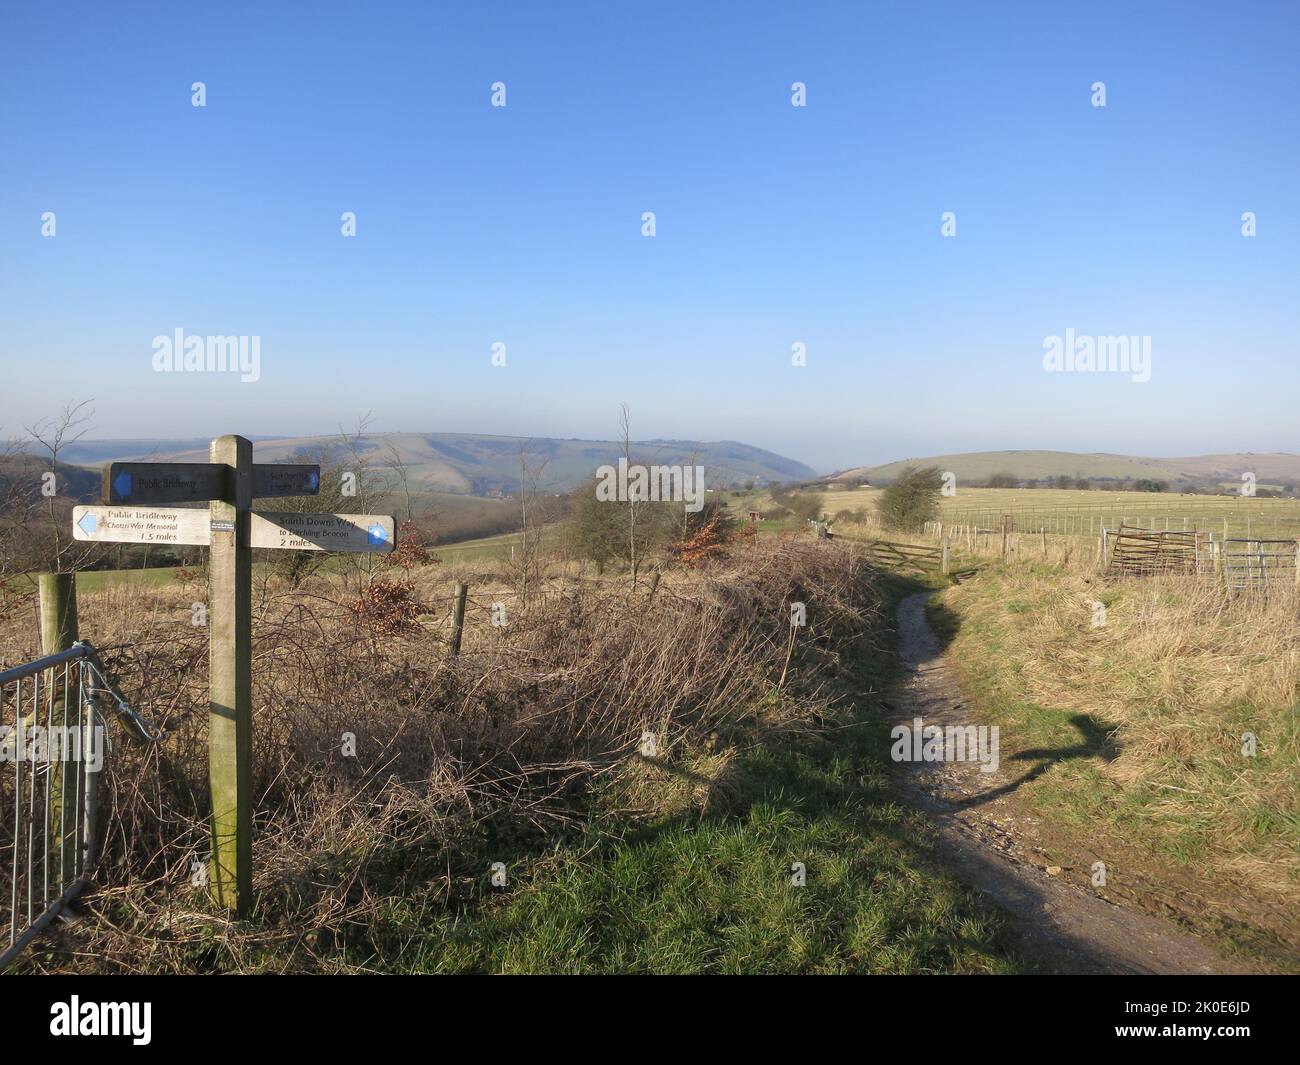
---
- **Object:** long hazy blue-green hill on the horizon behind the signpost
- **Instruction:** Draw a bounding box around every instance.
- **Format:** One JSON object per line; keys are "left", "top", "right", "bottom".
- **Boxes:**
{"left": 64, "top": 433, "right": 815, "bottom": 495}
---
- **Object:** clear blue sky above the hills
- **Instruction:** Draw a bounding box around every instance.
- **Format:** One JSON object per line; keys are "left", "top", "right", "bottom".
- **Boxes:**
{"left": 0, "top": 3, "right": 1300, "bottom": 468}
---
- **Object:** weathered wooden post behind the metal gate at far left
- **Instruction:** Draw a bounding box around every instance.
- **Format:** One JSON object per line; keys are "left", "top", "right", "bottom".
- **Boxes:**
{"left": 33, "top": 573, "right": 82, "bottom": 889}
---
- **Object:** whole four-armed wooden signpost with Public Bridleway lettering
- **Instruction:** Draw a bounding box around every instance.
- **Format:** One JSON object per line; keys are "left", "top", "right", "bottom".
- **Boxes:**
{"left": 73, "top": 436, "right": 397, "bottom": 914}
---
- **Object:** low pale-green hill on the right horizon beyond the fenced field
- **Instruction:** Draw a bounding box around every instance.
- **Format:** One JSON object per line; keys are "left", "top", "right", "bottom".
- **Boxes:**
{"left": 831, "top": 451, "right": 1300, "bottom": 488}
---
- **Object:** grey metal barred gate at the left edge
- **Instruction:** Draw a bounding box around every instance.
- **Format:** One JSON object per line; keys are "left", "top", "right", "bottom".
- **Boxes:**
{"left": 0, "top": 642, "right": 157, "bottom": 965}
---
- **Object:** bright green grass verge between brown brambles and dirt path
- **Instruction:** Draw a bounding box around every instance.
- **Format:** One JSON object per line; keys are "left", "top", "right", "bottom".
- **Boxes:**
{"left": 345, "top": 650, "right": 1022, "bottom": 974}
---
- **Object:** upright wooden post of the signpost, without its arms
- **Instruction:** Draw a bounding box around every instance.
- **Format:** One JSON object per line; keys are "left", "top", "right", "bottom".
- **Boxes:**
{"left": 208, "top": 436, "right": 252, "bottom": 915}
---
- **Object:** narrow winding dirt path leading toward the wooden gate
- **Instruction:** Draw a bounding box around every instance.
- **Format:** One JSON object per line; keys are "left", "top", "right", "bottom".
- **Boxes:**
{"left": 887, "top": 592, "right": 1255, "bottom": 974}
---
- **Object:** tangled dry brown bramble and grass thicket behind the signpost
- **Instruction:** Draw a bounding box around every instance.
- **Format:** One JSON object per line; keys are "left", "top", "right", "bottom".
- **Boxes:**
{"left": 0, "top": 541, "right": 879, "bottom": 971}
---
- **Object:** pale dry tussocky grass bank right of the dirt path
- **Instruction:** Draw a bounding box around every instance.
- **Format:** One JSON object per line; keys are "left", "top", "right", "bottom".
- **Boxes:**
{"left": 932, "top": 564, "right": 1300, "bottom": 947}
